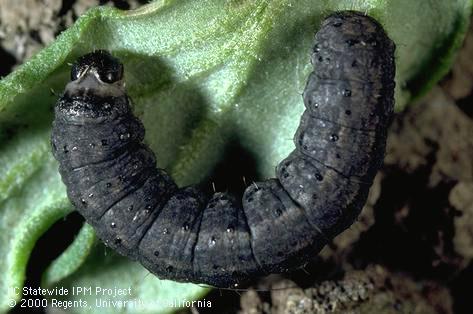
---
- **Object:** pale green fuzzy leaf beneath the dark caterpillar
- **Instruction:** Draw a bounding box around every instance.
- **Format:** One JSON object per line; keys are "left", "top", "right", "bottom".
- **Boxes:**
{"left": 0, "top": 0, "right": 472, "bottom": 313}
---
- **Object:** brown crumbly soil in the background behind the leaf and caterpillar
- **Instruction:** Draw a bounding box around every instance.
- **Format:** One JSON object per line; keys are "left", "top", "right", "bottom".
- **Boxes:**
{"left": 0, "top": 0, "right": 473, "bottom": 314}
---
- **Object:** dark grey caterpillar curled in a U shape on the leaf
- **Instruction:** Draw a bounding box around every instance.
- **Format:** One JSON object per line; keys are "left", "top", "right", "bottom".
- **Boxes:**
{"left": 52, "top": 11, "right": 395, "bottom": 287}
